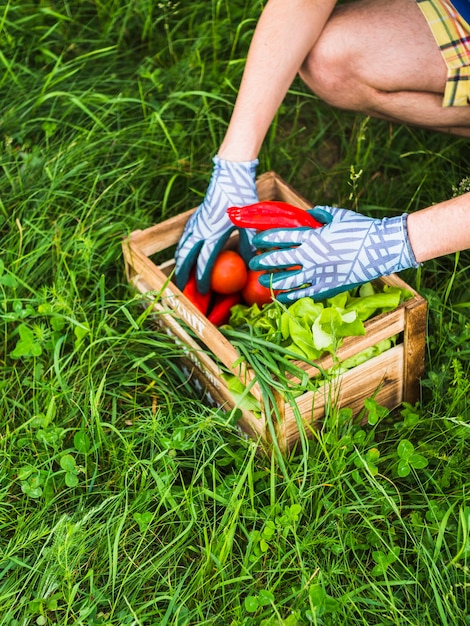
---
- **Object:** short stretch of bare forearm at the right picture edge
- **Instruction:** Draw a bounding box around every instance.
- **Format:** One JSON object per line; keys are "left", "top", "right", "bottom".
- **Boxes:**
{"left": 408, "top": 193, "right": 470, "bottom": 263}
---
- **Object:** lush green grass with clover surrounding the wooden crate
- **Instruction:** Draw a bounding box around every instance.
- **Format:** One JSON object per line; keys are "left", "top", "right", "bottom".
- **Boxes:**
{"left": 0, "top": 0, "right": 470, "bottom": 626}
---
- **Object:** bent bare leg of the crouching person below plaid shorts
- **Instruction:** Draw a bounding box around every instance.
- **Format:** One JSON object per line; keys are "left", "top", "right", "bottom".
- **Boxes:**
{"left": 300, "top": 0, "right": 470, "bottom": 137}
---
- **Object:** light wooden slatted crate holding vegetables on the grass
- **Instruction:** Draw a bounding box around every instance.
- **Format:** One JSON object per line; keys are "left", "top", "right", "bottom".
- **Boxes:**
{"left": 122, "top": 172, "right": 427, "bottom": 451}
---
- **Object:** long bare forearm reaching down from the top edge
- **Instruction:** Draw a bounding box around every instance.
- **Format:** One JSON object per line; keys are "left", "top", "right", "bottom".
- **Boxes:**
{"left": 218, "top": 0, "right": 336, "bottom": 161}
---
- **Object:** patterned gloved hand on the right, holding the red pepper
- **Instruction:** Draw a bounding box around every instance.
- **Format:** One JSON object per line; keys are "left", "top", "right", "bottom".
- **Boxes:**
{"left": 250, "top": 206, "right": 419, "bottom": 302}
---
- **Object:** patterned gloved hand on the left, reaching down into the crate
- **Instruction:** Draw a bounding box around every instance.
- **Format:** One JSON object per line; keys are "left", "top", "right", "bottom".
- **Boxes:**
{"left": 175, "top": 156, "right": 258, "bottom": 294}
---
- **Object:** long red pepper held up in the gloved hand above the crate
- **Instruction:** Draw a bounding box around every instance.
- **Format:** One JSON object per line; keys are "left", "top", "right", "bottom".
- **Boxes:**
{"left": 227, "top": 200, "right": 323, "bottom": 230}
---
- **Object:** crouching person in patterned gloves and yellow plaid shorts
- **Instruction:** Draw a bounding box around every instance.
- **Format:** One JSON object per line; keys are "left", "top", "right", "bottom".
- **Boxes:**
{"left": 175, "top": 0, "right": 470, "bottom": 302}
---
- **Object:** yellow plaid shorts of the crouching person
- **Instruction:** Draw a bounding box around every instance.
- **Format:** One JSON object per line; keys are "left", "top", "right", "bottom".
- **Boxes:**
{"left": 417, "top": 0, "right": 470, "bottom": 106}
